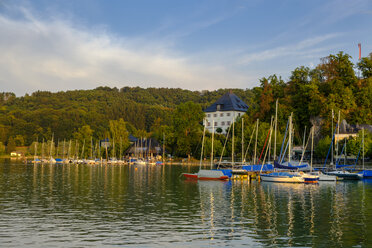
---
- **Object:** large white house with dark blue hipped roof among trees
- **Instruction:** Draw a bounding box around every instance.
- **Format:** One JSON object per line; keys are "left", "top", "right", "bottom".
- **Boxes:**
{"left": 203, "top": 91, "right": 248, "bottom": 134}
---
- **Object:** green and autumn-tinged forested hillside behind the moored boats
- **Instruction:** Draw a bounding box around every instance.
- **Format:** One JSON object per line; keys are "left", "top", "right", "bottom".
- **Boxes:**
{"left": 0, "top": 52, "right": 372, "bottom": 156}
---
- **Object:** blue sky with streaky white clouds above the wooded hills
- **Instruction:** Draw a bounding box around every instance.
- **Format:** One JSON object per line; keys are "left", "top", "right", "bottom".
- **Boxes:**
{"left": 0, "top": 0, "right": 372, "bottom": 96}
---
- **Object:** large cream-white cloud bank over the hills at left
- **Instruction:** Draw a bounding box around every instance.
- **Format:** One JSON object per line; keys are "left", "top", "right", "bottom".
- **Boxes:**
{"left": 0, "top": 6, "right": 249, "bottom": 94}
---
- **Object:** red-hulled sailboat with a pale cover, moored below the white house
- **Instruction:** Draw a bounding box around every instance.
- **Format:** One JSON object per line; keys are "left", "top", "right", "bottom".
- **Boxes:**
{"left": 182, "top": 121, "right": 229, "bottom": 180}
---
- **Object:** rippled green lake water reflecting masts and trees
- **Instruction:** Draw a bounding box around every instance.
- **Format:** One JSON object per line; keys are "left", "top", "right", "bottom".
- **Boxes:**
{"left": 0, "top": 162, "right": 372, "bottom": 247}
